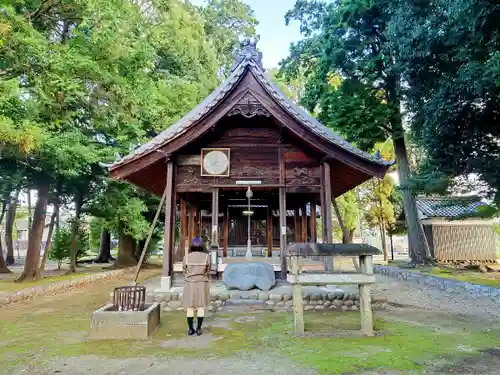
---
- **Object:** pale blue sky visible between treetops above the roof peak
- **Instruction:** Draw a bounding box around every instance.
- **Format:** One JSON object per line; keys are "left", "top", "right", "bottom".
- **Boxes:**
{"left": 191, "top": 0, "right": 301, "bottom": 69}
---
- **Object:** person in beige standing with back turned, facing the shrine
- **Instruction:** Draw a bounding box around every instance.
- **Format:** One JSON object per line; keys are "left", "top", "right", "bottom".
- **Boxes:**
{"left": 182, "top": 237, "right": 210, "bottom": 336}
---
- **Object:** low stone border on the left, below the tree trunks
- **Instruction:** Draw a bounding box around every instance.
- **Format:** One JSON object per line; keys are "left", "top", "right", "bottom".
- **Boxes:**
{"left": 0, "top": 266, "right": 135, "bottom": 307}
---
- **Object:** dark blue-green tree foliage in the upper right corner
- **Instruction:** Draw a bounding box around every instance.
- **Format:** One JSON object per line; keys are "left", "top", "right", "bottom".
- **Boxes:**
{"left": 389, "top": 0, "right": 500, "bottom": 203}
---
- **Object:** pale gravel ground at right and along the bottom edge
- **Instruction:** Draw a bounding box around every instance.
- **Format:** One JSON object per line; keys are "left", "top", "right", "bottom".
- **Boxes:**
{"left": 6, "top": 276, "right": 500, "bottom": 375}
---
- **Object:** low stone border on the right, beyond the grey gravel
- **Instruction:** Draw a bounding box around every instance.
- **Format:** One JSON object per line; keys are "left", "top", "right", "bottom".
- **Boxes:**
{"left": 373, "top": 265, "right": 500, "bottom": 304}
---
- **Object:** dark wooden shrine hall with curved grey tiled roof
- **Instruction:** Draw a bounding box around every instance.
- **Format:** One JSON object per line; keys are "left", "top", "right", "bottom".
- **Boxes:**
{"left": 109, "top": 39, "right": 390, "bottom": 289}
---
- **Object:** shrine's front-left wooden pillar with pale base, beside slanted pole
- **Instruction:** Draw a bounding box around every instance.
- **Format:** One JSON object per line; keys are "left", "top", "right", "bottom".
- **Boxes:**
{"left": 161, "top": 160, "right": 175, "bottom": 289}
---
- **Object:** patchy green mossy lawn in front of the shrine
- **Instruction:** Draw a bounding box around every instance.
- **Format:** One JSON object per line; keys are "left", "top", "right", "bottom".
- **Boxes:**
{"left": 0, "top": 269, "right": 500, "bottom": 374}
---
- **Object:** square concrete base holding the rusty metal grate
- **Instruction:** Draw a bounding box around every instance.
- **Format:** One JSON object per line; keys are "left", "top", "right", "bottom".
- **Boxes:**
{"left": 90, "top": 303, "right": 160, "bottom": 340}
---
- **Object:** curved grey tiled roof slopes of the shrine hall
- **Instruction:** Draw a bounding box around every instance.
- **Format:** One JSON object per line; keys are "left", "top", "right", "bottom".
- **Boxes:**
{"left": 109, "top": 46, "right": 392, "bottom": 169}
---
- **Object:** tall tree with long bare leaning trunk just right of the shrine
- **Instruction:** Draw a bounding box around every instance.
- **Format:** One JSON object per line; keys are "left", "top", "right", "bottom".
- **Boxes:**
{"left": 282, "top": 0, "right": 430, "bottom": 263}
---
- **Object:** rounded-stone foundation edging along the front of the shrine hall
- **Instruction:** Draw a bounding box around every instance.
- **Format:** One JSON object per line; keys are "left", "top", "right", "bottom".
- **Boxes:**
{"left": 152, "top": 286, "right": 388, "bottom": 311}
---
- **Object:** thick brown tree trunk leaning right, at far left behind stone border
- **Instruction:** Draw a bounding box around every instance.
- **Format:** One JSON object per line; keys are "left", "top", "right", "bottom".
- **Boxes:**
{"left": 16, "top": 184, "right": 49, "bottom": 282}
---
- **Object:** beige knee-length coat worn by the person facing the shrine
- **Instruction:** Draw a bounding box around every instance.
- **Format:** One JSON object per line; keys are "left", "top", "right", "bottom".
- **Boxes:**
{"left": 182, "top": 251, "right": 210, "bottom": 308}
